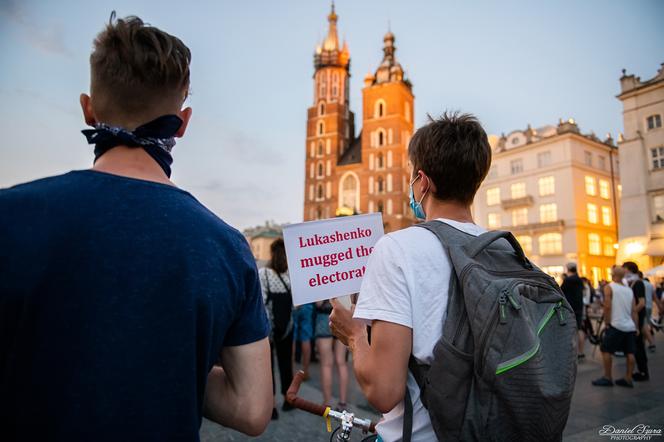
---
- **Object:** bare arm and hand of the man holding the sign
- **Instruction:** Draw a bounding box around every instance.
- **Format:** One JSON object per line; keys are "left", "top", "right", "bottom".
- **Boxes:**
{"left": 330, "top": 300, "right": 413, "bottom": 413}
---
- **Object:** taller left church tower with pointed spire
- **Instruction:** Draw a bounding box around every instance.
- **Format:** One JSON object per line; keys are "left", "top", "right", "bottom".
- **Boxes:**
{"left": 304, "top": 3, "right": 355, "bottom": 221}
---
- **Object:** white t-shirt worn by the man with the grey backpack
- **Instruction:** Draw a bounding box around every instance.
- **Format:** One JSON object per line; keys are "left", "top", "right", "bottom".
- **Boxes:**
{"left": 354, "top": 219, "right": 485, "bottom": 442}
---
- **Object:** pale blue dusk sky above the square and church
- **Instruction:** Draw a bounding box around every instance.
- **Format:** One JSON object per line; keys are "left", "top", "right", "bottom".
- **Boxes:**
{"left": 0, "top": 0, "right": 664, "bottom": 229}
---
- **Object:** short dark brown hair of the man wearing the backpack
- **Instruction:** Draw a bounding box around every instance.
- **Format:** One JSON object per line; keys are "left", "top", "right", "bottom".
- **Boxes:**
{"left": 408, "top": 112, "right": 491, "bottom": 204}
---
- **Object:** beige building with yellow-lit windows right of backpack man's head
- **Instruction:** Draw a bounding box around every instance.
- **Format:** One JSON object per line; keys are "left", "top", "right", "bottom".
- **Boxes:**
{"left": 473, "top": 120, "right": 620, "bottom": 283}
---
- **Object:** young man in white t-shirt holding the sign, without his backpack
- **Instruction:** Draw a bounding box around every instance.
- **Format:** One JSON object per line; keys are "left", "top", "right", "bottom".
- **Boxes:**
{"left": 330, "top": 113, "right": 491, "bottom": 442}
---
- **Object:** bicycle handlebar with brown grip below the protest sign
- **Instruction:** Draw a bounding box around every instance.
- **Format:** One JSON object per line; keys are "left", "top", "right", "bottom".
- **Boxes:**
{"left": 286, "top": 370, "right": 376, "bottom": 442}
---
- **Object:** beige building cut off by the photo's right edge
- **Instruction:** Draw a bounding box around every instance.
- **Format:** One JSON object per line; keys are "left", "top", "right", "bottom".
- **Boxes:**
{"left": 618, "top": 63, "right": 664, "bottom": 270}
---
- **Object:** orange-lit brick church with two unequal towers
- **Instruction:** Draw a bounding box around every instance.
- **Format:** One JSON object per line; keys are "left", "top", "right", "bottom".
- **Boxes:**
{"left": 304, "top": 4, "right": 414, "bottom": 231}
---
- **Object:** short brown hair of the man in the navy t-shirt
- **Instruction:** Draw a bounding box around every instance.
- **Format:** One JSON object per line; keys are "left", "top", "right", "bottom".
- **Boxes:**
{"left": 90, "top": 11, "right": 191, "bottom": 123}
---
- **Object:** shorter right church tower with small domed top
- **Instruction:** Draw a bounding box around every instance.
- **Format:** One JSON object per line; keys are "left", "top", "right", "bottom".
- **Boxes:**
{"left": 362, "top": 32, "right": 414, "bottom": 231}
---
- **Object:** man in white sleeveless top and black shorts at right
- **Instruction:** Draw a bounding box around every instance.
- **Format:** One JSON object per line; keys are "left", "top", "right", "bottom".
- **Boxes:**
{"left": 592, "top": 266, "right": 639, "bottom": 388}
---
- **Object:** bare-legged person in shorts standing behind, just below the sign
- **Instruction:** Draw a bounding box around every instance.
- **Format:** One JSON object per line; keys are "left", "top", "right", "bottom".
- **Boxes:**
{"left": 315, "top": 300, "right": 348, "bottom": 410}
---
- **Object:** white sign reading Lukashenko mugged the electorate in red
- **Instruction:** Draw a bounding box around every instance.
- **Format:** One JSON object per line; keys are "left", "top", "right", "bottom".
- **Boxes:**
{"left": 284, "top": 213, "right": 383, "bottom": 305}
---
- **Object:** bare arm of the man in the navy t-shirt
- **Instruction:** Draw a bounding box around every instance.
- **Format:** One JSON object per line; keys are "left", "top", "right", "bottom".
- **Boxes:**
{"left": 203, "top": 338, "right": 272, "bottom": 436}
